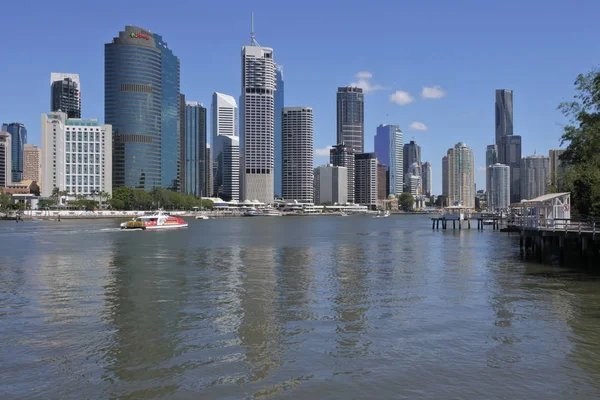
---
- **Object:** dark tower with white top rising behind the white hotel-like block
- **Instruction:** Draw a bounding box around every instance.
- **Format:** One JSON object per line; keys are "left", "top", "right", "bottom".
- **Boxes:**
{"left": 50, "top": 72, "right": 81, "bottom": 118}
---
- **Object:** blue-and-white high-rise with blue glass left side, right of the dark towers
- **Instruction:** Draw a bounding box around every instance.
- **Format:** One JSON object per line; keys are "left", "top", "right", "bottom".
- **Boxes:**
{"left": 375, "top": 125, "right": 404, "bottom": 195}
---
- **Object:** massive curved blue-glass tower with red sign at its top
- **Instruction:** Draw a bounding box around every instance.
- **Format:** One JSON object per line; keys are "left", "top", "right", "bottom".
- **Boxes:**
{"left": 104, "top": 26, "right": 181, "bottom": 190}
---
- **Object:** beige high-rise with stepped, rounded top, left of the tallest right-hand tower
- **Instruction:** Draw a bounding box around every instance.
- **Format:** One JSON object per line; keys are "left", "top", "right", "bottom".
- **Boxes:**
{"left": 446, "top": 142, "right": 475, "bottom": 208}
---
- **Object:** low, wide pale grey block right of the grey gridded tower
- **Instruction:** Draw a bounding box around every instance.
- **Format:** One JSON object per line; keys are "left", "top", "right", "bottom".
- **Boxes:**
{"left": 314, "top": 164, "right": 348, "bottom": 205}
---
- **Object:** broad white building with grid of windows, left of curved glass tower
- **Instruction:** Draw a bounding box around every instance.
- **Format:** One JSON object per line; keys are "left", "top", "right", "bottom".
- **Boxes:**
{"left": 41, "top": 112, "right": 113, "bottom": 198}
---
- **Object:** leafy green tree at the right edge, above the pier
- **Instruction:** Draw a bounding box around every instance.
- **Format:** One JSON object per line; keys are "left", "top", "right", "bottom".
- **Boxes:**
{"left": 558, "top": 70, "right": 600, "bottom": 216}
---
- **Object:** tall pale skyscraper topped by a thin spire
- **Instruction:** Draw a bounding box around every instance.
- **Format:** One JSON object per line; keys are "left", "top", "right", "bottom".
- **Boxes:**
{"left": 242, "top": 32, "right": 276, "bottom": 204}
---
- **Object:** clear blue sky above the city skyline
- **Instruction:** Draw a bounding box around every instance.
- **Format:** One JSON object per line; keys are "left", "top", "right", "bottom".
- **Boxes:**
{"left": 0, "top": 0, "right": 600, "bottom": 193}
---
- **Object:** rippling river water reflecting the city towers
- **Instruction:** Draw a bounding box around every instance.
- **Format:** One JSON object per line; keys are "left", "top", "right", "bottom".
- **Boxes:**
{"left": 0, "top": 216, "right": 600, "bottom": 399}
